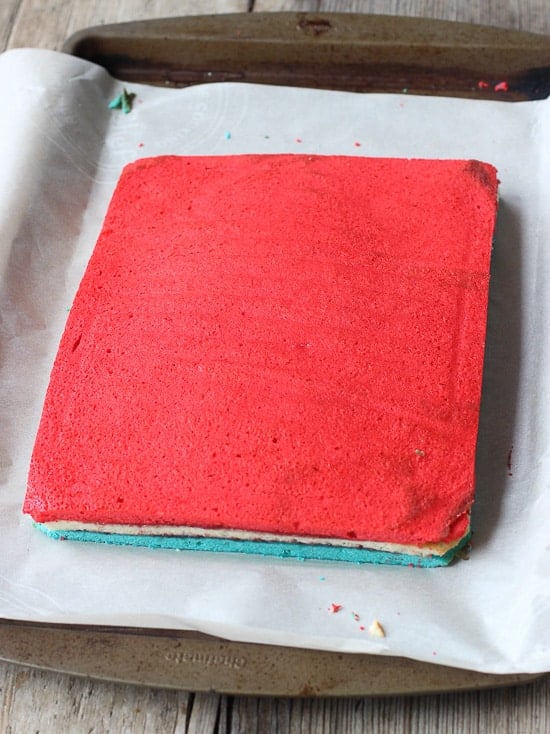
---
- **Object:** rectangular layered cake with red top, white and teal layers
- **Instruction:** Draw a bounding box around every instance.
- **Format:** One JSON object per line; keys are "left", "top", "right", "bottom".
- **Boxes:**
{"left": 23, "top": 155, "right": 497, "bottom": 566}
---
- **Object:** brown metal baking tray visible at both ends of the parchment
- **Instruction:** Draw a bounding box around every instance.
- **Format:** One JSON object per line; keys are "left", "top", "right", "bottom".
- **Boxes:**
{"left": 0, "top": 13, "right": 550, "bottom": 696}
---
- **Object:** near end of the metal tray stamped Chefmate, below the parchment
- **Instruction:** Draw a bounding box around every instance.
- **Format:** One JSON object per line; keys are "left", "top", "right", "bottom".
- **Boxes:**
{"left": 0, "top": 618, "right": 548, "bottom": 698}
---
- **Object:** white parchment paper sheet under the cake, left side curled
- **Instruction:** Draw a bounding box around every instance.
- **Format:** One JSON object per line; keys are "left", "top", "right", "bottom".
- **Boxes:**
{"left": 0, "top": 50, "right": 550, "bottom": 673}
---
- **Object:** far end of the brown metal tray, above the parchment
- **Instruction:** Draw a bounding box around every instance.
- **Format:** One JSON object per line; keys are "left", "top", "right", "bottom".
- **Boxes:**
{"left": 62, "top": 11, "right": 550, "bottom": 101}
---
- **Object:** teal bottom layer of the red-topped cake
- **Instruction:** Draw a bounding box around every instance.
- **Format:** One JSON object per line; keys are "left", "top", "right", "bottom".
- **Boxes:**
{"left": 35, "top": 523, "right": 470, "bottom": 568}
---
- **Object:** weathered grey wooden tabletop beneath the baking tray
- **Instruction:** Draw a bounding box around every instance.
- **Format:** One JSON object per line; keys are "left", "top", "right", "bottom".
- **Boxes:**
{"left": 0, "top": 0, "right": 550, "bottom": 734}
